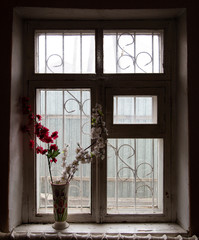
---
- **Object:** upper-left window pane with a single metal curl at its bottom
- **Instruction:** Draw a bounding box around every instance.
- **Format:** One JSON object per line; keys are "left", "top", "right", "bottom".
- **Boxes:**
{"left": 35, "top": 30, "right": 95, "bottom": 73}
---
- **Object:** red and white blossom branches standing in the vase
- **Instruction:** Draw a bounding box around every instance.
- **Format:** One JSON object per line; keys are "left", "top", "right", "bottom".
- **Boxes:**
{"left": 22, "top": 97, "right": 108, "bottom": 184}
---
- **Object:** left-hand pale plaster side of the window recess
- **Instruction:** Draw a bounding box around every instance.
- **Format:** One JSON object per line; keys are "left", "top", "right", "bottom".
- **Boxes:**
{"left": 9, "top": 11, "right": 23, "bottom": 230}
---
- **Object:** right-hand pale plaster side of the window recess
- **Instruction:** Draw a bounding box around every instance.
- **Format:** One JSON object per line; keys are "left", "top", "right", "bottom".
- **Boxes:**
{"left": 174, "top": 13, "right": 190, "bottom": 230}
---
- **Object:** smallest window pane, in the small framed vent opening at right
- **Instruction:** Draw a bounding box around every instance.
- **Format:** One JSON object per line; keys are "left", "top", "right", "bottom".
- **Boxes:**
{"left": 113, "top": 96, "right": 157, "bottom": 124}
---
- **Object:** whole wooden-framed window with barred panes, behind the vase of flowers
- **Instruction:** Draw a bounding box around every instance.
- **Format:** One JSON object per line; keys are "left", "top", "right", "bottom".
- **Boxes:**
{"left": 24, "top": 21, "right": 173, "bottom": 222}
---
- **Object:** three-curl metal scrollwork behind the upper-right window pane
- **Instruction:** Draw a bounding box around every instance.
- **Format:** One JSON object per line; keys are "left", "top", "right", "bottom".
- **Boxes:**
{"left": 117, "top": 32, "right": 153, "bottom": 73}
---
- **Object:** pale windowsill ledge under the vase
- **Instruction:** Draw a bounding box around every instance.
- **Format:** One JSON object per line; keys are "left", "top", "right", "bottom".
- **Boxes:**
{"left": 12, "top": 223, "right": 188, "bottom": 236}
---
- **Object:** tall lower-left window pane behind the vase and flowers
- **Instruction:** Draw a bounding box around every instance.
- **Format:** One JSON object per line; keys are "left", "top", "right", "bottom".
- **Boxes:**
{"left": 36, "top": 89, "right": 91, "bottom": 213}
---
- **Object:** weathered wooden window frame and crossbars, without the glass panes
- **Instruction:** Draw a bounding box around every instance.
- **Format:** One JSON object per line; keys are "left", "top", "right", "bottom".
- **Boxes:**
{"left": 23, "top": 20, "right": 175, "bottom": 223}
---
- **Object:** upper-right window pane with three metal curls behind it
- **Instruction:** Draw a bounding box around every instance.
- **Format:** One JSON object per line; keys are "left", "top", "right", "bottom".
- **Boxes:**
{"left": 104, "top": 30, "right": 163, "bottom": 73}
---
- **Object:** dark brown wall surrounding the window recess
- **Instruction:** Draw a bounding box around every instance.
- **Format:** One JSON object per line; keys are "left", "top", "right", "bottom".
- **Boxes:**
{"left": 0, "top": 0, "right": 199, "bottom": 234}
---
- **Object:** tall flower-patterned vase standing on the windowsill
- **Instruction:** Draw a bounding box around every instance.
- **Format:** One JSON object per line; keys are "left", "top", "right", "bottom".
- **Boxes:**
{"left": 51, "top": 183, "right": 69, "bottom": 230}
